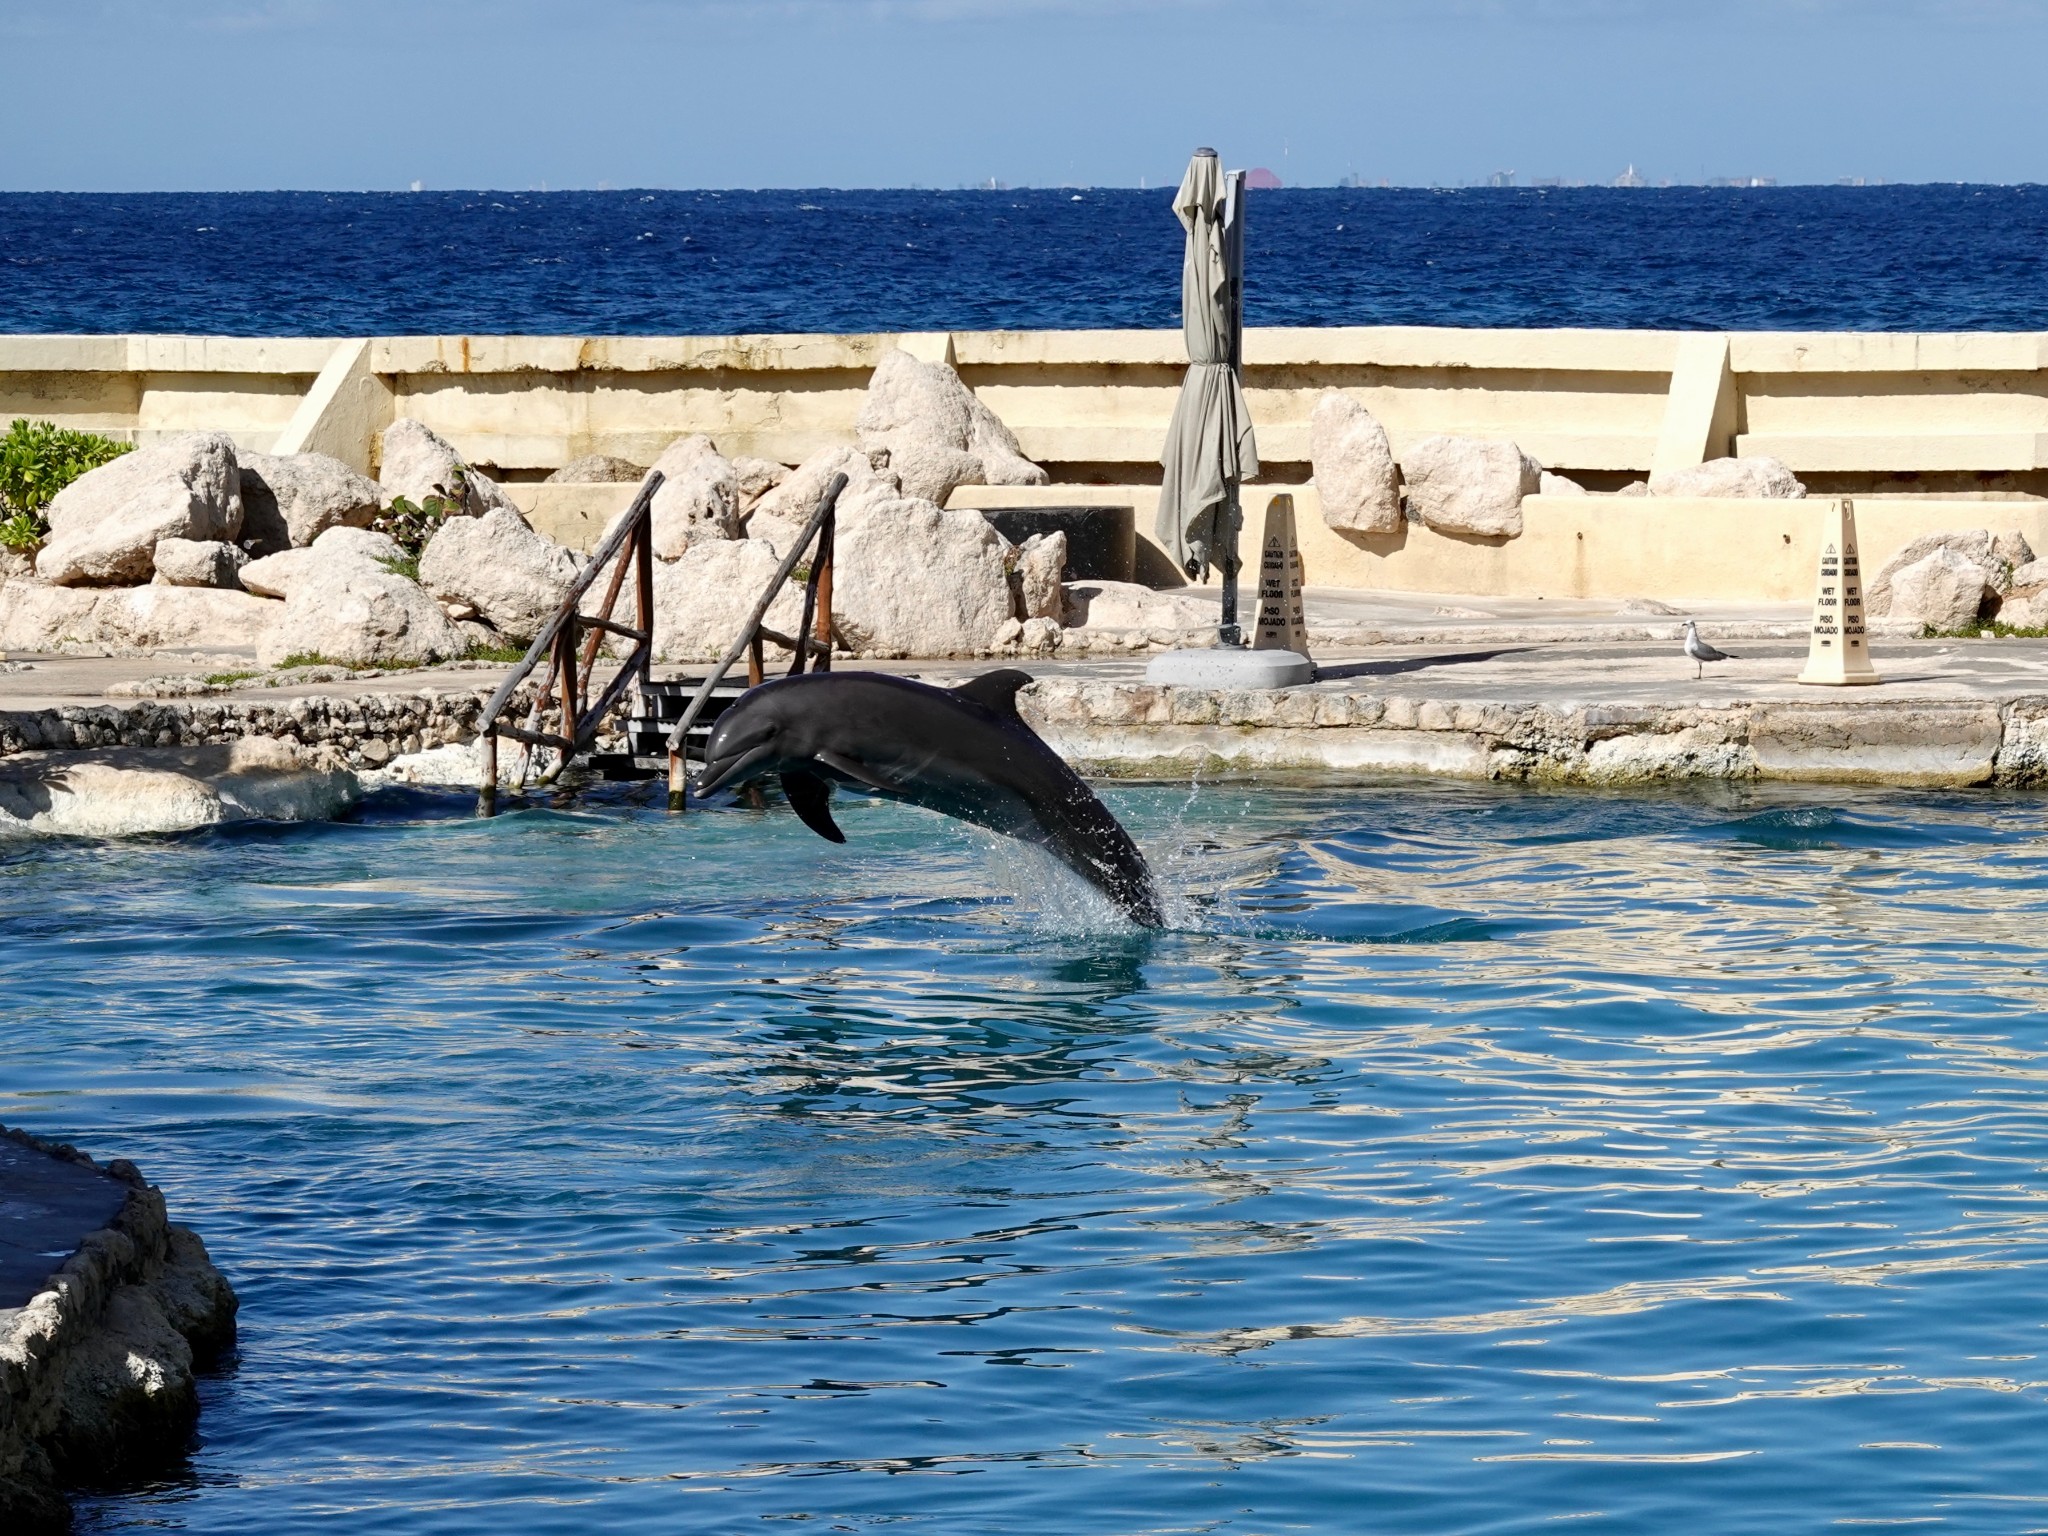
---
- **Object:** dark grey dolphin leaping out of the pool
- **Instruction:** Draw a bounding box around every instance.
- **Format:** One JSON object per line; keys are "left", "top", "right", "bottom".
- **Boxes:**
{"left": 694, "top": 668, "right": 1165, "bottom": 928}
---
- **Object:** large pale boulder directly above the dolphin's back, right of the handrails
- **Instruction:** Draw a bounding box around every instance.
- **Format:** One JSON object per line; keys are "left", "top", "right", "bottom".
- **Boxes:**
{"left": 831, "top": 498, "right": 1012, "bottom": 655}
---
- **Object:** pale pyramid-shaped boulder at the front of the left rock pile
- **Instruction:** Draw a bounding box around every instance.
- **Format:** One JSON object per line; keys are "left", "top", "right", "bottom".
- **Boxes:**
{"left": 256, "top": 561, "right": 469, "bottom": 668}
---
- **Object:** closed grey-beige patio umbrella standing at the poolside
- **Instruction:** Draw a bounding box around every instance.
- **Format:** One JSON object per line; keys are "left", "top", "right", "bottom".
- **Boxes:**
{"left": 1155, "top": 150, "right": 1260, "bottom": 645}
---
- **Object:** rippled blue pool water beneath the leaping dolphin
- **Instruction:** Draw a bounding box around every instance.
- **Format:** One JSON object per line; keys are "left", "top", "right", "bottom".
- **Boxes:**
{"left": 0, "top": 782, "right": 2048, "bottom": 1536}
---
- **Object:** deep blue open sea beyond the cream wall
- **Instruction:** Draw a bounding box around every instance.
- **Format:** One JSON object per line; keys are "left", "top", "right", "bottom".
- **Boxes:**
{"left": 12, "top": 186, "right": 2048, "bottom": 336}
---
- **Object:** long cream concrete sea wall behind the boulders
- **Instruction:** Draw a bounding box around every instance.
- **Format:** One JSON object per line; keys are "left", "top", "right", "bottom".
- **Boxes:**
{"left": 0, "top": 328, "right": 2048, "bottom": 600}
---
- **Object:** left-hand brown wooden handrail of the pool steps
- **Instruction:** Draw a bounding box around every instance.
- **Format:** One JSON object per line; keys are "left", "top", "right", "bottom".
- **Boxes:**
{"left": 477, "top": 473, "right": 662, "bottom": 815}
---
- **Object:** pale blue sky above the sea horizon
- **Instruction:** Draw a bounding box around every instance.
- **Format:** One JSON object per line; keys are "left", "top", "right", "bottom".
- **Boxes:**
{"left": 0, "top": 0, "right": 2048, "bottom": 190}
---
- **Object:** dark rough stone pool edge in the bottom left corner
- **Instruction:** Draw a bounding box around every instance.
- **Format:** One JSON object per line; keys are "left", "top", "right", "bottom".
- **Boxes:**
{"left": 0, "top": 1126, "right": 240, "bottom": 1536}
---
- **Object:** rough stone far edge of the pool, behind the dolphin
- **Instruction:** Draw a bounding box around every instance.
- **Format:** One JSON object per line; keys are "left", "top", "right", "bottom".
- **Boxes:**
{"left": 0, "top": 676, "right": 2048, "bottom": 788}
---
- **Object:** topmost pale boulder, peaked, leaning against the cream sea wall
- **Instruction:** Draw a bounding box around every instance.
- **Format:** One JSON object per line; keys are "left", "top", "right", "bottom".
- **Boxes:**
{"left": 854, "top": 348, "right": 1047, "bottom": 504}
